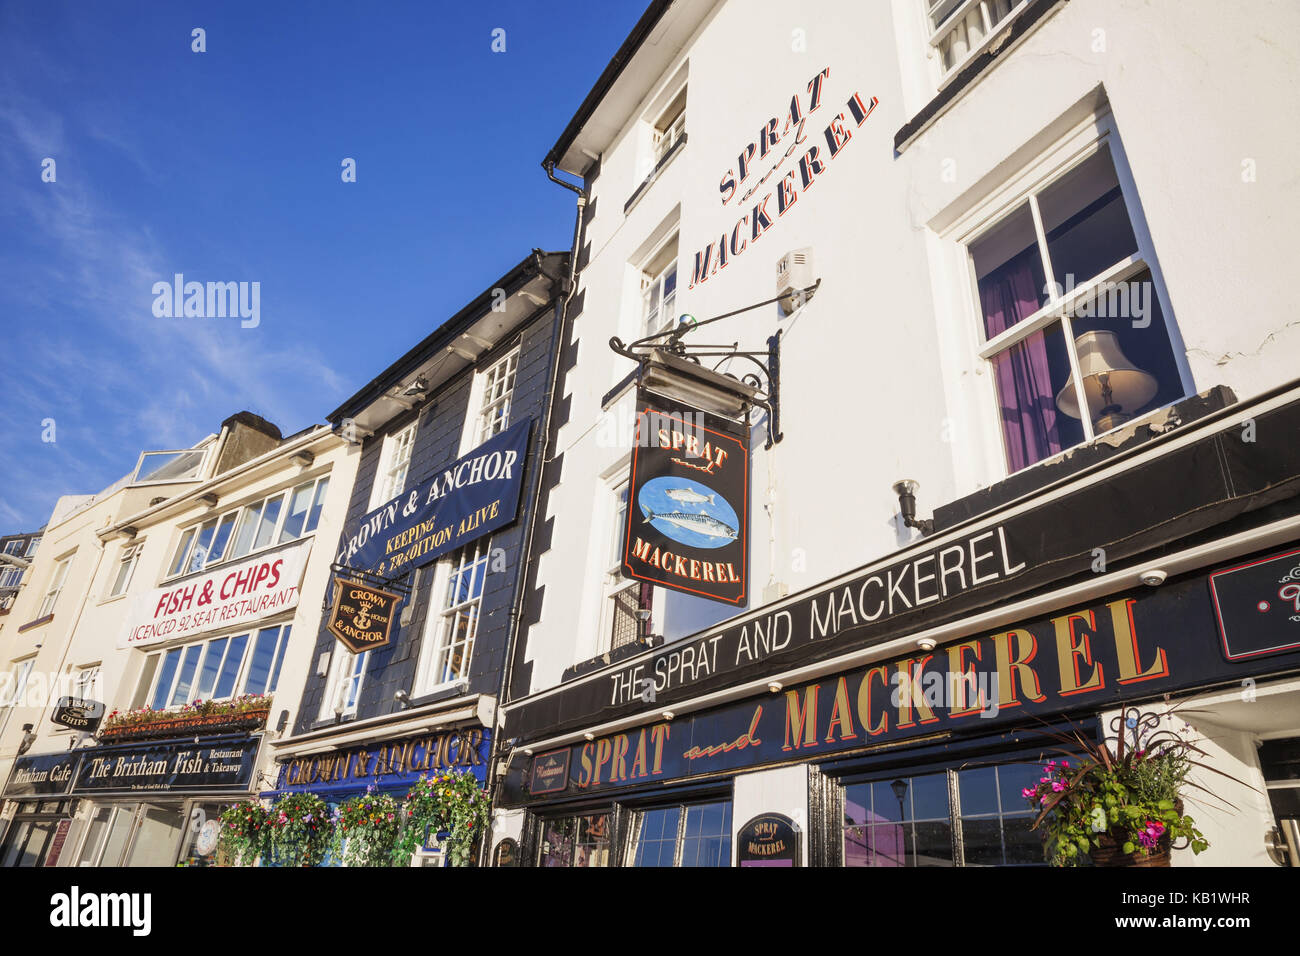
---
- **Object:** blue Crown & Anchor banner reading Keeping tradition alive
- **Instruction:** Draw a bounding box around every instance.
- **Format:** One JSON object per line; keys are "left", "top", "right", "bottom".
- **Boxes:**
{"left": 338, "top": 419, "right": 532, "bottom": 578}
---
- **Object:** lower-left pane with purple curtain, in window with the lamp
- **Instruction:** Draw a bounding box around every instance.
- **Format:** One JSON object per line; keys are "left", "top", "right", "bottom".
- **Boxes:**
{"left": 992, "top": 325, "right": 1083, "bottom": 471}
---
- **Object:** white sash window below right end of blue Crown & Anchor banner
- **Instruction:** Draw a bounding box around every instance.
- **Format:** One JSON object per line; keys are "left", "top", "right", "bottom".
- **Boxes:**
{"left": 416, "top": 538, "right": 491, "bottom": 693}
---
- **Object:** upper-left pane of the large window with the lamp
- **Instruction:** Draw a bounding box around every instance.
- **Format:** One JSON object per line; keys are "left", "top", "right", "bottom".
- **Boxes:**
{"left": 970, "top": 204, "right": 1048, "bottom": 338}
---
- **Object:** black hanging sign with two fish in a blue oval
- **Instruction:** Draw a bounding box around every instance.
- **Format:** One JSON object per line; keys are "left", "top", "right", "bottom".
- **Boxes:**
{"left": 623, "top": 389, "right": 749, "bottom": 605}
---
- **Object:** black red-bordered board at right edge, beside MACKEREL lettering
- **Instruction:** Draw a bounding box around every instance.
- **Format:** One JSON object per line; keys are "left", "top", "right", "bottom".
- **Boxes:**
{"left": 1210, "top": 550, "right": 1300, "bottom": 661}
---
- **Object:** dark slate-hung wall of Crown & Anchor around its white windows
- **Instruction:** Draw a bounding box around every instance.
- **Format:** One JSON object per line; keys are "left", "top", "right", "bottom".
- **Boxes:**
{"left": 294, "top": 306, "right": 556, "bottom": 734}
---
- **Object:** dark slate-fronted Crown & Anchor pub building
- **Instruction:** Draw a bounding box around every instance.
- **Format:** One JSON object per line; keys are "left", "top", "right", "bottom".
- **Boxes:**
{"left": 263, "top": 250, "right": 569, "bottom": 866}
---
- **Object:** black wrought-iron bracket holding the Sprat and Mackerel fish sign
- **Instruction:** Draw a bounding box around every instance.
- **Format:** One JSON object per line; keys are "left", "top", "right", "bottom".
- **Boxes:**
{"left": 610, "top": 280, "right": 822, "bottom": 449}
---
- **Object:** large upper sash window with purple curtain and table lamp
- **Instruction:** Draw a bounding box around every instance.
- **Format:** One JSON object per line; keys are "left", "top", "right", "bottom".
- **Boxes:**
{"left": 967, "top": 139, "right": 1187, "bottom": 472}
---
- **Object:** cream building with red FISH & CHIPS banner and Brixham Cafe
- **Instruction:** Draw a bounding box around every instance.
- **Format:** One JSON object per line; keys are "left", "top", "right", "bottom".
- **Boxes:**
{"left": 0, "top": 412, "right": 359, "bottom": 866}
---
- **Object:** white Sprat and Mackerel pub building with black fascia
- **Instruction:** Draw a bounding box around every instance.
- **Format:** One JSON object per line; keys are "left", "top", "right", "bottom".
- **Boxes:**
{"left": 493, "top": 0, "right": 1300, "bottom": 866}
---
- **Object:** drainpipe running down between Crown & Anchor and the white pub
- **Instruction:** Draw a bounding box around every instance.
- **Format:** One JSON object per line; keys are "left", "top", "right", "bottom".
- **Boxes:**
{"left": 478, "top": 163, "right": 586, "bottom": 866}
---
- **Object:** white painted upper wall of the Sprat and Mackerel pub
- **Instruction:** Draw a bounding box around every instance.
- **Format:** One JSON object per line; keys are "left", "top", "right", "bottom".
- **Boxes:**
{"left": 527, "top": 0, "right": 1300, "bottom": 691}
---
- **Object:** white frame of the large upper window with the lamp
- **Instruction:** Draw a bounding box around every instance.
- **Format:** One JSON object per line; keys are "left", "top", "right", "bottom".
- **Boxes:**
{"left": 945, "top": 109, "right": 1195, "bottom": 476}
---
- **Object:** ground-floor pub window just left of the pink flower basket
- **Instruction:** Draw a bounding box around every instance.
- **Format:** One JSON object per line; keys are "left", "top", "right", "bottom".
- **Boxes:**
{"left": 841, "top": 762, "right": 1044, "bottom": 866}
